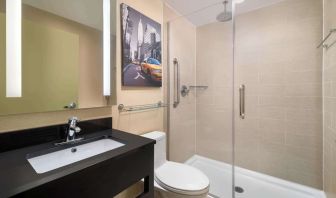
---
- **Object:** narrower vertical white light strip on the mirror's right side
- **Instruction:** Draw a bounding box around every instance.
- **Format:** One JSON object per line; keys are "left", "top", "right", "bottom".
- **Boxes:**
{"left": 103, "top": 0, "right": 111, "bottom": 96}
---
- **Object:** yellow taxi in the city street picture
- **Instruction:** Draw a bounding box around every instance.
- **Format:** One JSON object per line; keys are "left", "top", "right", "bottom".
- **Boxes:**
{"left": 141, "top": 58, "right": 162, "bottom": 82}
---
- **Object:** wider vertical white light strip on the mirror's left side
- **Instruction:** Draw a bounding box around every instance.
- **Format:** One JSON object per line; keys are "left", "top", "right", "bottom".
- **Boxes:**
{"left": 6, "top": 0, "right": 22, "bottom": 97}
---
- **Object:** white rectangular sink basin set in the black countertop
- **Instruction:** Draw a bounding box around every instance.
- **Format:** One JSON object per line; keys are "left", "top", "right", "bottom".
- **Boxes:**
{"left": 27, "top": 138, "right": 125, "bottom": 174}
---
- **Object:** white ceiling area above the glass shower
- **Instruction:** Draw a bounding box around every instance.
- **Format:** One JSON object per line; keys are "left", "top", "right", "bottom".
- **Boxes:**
{"left": 163, "top": 0, "right": 284, "bottom": 26}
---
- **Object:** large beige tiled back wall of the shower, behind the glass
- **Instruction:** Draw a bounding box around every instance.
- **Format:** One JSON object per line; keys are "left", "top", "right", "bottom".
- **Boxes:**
{"left": 196, "top": 0, "right": 322, "bottom": 188}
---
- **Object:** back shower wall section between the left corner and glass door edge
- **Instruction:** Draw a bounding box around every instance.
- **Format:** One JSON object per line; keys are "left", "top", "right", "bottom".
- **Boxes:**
{"left": 196, "top": 23, "right": 233, "bottom": 164}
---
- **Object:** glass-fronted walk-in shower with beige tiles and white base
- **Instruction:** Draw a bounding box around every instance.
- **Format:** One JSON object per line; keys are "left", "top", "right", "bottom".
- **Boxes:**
{"left": 164, "top": 0, "right": 336, "bottom": 198}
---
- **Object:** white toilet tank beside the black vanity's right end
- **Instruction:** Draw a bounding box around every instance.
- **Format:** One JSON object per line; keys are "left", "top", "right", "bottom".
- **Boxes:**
{"left": 142, "top": 131, "right": 167, "bottom": 169}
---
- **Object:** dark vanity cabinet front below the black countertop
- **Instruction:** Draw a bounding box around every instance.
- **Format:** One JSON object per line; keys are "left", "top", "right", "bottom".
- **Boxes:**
{"left": 14, "top": 145, "right": 154, "bottom": 198}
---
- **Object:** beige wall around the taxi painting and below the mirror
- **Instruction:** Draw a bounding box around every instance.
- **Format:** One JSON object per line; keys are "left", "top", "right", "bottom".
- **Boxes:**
{"left": 0, "top": 0, "right": 165, "bottom": 197}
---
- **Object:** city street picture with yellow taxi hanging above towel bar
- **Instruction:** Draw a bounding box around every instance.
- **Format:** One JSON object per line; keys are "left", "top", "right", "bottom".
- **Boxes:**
{"left": 121, "top": 4, "right": 162, "bottom": 87}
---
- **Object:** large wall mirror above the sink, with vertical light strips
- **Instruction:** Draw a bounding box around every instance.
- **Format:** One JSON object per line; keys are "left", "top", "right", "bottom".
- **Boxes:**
{"left": 0, "top": 0, "right": 116, "bottom": 115}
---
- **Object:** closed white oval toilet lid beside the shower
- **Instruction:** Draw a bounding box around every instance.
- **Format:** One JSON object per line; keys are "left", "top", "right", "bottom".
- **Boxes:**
{"left": 155, "top": 162, "right": 209, "bottom": 195}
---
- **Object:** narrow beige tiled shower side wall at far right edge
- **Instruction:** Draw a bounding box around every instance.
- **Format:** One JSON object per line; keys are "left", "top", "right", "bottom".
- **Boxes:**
{"left": 323, "top": 0, "right": 336, "bottom": 198}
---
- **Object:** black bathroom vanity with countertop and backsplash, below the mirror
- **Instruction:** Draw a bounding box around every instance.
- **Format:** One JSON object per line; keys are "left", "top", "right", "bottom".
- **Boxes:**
{"left": 0, "top": 118, "right": 155, "bottom": 198}
